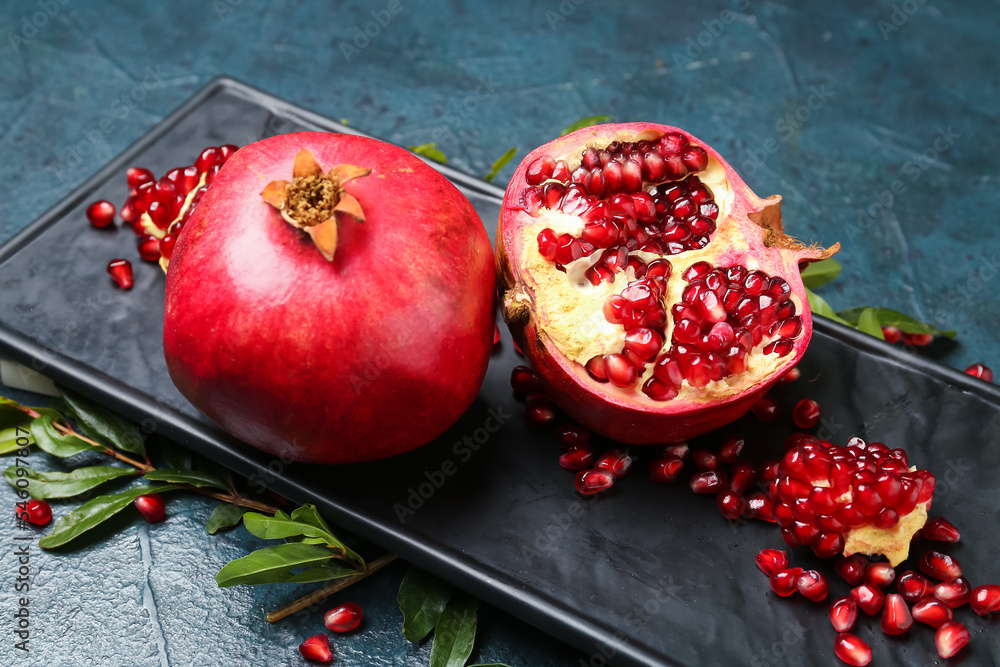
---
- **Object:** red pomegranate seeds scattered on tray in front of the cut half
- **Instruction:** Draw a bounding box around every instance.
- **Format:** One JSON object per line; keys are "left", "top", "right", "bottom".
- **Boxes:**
{"left": 511, "top": 366, "right": 1000, "bottom": 666}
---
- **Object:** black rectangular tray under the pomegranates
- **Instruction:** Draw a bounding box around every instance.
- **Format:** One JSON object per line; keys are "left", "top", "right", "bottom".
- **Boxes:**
{"left": 0, "top": 77, "right": 1000, "bottom": 667}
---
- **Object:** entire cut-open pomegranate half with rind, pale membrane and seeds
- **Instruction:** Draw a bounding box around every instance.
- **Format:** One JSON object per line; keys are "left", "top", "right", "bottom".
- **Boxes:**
{"left": 497, "top": 123, "right": 839, "bottom": 444}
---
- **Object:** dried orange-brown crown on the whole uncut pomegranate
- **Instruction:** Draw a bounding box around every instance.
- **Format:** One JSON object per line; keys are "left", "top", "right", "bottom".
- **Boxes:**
{"left": 260, "top": 148, "right": 372, "bottom": 262}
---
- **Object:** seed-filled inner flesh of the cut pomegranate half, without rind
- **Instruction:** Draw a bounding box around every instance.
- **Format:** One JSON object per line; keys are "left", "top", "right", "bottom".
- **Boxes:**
{"left": 520, "top": 133, "right": 803, "bottom": 402}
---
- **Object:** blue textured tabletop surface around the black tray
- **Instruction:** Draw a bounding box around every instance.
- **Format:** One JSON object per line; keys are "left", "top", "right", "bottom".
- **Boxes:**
{"left": 0, "top": 0, "right": 1000, "bottom": 665}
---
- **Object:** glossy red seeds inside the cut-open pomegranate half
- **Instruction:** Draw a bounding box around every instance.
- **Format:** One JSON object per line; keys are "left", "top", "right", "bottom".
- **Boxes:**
{"left": 521, "top": 133, "right": 802, "bottom": 401}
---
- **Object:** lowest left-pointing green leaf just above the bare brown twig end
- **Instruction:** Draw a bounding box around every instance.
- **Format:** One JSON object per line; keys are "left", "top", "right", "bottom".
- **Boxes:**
{"left": 215, "top": 544, "right": 358, "bottom": 588}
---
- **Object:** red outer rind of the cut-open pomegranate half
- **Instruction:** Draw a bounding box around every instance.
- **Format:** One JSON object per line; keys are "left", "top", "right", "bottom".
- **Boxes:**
{"left": 496, "top": 123, "right": 840, "bottom": 445}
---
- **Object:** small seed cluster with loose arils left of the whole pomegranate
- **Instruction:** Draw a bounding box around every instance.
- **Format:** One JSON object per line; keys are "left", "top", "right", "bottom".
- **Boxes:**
{"left": 87, "top": 144, "right": 238, "bottom": 290}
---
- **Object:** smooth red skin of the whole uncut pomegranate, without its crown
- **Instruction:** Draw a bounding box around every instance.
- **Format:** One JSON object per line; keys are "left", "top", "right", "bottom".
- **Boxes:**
{"left": 163, "top": 132, "right": 495, "bottom": 463}
